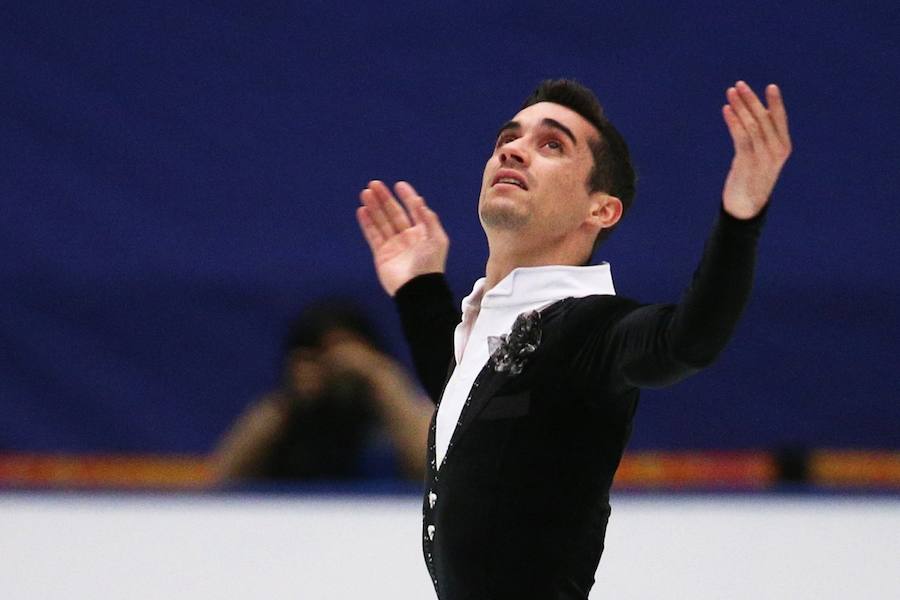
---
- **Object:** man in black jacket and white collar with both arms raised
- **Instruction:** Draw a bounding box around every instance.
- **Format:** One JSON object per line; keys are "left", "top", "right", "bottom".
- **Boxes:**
{"left": 357, "top": 80, "right": 790, "bottom": 600}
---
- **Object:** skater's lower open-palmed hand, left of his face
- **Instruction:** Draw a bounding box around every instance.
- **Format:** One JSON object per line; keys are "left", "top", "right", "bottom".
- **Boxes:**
{"left": 356, "top": 181, "right": 450, "bottom": 296}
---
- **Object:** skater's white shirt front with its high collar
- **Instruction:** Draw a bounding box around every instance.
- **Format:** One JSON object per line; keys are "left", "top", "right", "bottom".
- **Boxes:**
{"left": 435, "top": 263, "right": 616, "bottom": 467}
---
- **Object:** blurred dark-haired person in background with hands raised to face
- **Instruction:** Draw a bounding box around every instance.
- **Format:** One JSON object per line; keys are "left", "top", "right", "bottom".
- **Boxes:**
{"left": 210, "top": 299, "right": 433, "bottom": 484}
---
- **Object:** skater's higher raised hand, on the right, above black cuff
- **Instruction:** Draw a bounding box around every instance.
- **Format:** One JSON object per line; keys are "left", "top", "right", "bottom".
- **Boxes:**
{"left": 722, "top": 81, "right": 791, "bottom": 219}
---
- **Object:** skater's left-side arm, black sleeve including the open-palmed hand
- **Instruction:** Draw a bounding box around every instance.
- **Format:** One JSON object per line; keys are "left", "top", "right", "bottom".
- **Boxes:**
{"left": 356, "top": 181, "right": 459, "bottom": 402}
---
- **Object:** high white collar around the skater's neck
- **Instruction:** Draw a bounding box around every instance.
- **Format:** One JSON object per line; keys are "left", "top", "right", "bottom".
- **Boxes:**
{"left": 462, "top": 262, "right": 616, "bottom": 312}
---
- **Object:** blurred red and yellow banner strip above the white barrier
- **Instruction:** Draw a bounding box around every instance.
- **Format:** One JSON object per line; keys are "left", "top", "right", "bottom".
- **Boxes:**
{"left": 0, "top": 450, "right": 900, "bottom": 490}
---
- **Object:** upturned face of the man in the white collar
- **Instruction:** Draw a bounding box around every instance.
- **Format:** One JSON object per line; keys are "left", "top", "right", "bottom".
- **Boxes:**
{"left": 478, "top": 102, "right": 599, "bottom": 244}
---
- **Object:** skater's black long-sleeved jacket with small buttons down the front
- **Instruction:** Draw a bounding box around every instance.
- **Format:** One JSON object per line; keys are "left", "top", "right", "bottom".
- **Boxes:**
{"left": 395, "top": 210, "right": 764, "bottom": 600}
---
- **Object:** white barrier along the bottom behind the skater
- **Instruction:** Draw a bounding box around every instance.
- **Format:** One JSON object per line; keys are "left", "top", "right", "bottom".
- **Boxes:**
{"left": 0, "top": 493, "right": 900, "bottom": 600}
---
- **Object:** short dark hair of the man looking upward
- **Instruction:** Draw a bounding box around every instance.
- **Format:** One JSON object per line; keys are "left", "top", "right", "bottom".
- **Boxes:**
{"left": 519, "top": 79, "right": 636, "bottom": 254}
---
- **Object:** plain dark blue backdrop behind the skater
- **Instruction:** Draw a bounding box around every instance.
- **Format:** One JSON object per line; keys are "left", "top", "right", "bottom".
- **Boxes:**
{"left": 0, "top": 0, "right": 900, "bottom": 452}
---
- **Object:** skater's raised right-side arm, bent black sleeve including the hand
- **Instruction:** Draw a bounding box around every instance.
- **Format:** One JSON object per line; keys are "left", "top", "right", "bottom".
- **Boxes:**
{"left": 584, "top": 82, "right": 791, "bottom": 387}
